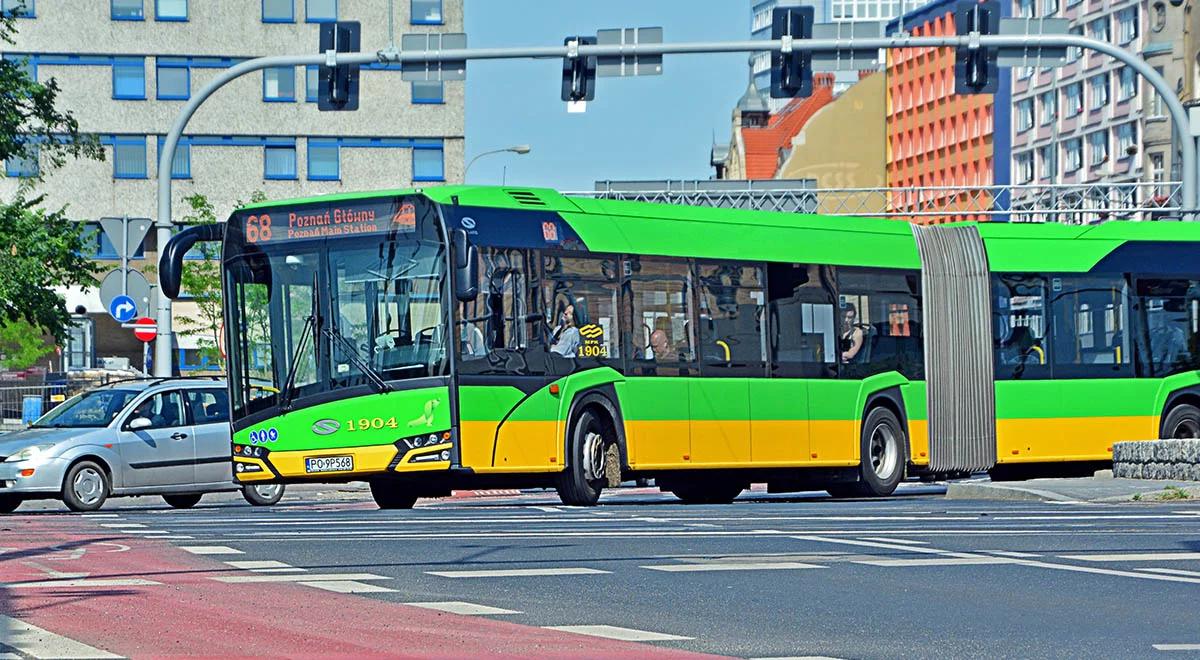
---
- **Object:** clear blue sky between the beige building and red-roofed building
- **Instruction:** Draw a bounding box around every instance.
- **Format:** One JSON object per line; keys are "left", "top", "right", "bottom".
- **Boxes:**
{"left": 466, "top": 0, "right": 750, "bottom": 190}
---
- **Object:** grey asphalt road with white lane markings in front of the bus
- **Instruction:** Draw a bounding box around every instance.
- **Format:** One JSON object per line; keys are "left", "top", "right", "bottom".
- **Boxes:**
{"left": 0, "top": 485, "right": 1200, "bottom": 658}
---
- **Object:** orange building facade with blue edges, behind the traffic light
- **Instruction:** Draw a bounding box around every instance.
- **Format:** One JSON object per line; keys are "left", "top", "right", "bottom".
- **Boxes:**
{"left": 886, "top": 0, "right": 1012, "bottom": 223}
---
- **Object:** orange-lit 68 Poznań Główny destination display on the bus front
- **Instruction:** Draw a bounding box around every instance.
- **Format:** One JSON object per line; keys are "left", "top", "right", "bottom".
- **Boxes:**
{"left": 234, "top": 197, "right": 424, "bottom": 245}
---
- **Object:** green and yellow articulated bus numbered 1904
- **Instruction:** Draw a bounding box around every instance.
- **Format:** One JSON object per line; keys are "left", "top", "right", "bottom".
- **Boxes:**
{"left": 161, "top": 186, "right": 1200, "bottom": 508}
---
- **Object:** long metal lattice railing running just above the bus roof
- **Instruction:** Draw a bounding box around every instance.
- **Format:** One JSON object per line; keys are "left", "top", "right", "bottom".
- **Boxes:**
{"left": 576, "top": 180, "right": 1183, "bottom": 224}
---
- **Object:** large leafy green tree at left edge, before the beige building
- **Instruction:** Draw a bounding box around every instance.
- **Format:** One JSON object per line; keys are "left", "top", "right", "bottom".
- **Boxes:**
{"left": 0, "top": 16, "right": 103, "bottom": 341}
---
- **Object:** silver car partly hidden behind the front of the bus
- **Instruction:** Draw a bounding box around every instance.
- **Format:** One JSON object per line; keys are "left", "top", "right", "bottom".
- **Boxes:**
{"left": 0, "top": 378, "right": 283, "bottom": 514}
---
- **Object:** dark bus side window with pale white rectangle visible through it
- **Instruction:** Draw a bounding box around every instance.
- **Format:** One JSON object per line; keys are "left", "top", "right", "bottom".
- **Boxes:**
{"left": 767, "top": 264, "right": 839, "bottom": 378}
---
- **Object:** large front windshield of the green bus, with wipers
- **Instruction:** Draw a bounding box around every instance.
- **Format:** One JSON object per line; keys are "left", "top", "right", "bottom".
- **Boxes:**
{"left": 226, "top": 196, "right": 449, "bottom": 420}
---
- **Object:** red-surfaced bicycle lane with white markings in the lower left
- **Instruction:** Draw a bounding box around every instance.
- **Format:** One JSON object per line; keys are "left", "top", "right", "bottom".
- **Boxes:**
{"left": 0, "top": 515, "right": 720, "bottom": 659}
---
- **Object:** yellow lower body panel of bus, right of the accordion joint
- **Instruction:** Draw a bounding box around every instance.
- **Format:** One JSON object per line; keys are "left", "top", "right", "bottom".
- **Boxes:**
{"left": 996, "top": 415, "right": 1158, "bottom": 463}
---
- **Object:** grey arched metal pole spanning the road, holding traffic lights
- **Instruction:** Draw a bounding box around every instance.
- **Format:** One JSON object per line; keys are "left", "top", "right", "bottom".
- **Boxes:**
{"left": 154, "top": 34, "right": 1200, "bottom": 377}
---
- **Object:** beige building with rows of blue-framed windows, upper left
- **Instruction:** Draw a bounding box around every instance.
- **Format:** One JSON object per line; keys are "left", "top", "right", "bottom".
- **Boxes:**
{"left": 0, "top": 0, "right": 464, "bottom": 368}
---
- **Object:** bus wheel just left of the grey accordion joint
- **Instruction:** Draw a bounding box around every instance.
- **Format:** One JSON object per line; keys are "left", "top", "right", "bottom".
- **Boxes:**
{"left": 826, "top": 406, "right": 908, "bottom": 497}
